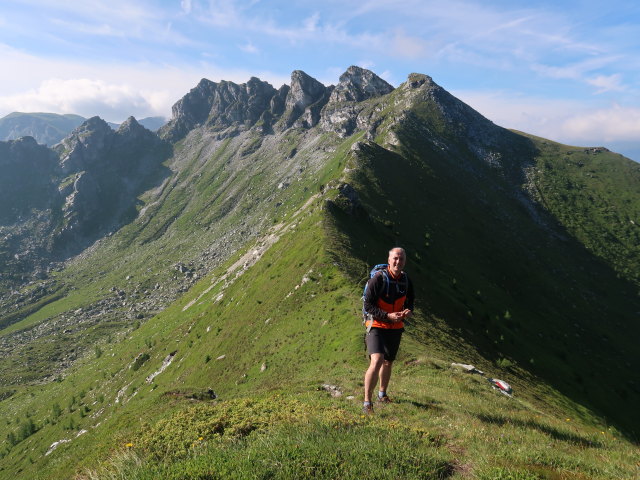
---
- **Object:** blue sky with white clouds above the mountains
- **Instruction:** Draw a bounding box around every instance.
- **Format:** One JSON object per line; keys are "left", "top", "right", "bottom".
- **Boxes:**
{"left": 0, "top": 0, "right": 640, "bottom": 161}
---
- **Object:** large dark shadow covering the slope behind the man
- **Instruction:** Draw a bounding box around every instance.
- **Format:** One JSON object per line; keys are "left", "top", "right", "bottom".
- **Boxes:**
{"left": 331, "top": 131, "right": 640, "bottom": 438}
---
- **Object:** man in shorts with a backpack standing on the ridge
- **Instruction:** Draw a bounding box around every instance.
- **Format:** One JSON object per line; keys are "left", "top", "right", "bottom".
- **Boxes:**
{"left": 363, "top": 247, "right": 414, "bottom": 414}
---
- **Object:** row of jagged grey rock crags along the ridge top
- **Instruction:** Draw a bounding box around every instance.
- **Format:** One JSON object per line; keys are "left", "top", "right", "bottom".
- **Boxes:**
{"left": 159, "top": 66, "right": 393, "bottom": 142}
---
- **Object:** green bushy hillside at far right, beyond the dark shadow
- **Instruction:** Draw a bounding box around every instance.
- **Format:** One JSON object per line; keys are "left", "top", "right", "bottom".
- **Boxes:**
{"left": 529, "top": 136, "right": 640, "bottom": 285}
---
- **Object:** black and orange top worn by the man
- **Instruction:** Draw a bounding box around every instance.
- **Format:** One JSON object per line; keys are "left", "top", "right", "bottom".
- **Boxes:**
{"left": 364, "top": 269, "right": 414, "bottom": 329}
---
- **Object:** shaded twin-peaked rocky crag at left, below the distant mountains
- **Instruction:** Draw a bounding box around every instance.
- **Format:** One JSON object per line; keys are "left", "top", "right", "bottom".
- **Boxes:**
{"left": 55, "top": 117, "right": 170, "bottom": 254}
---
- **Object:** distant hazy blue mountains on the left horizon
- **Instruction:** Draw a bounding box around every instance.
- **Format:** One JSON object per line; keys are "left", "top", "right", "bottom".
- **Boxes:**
{"left": 0, "top": 112, "right": 166, "bottom": 146}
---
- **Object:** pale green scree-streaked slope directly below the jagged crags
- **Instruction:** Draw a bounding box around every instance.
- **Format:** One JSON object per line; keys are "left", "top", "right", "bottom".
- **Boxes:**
{"left": 0, "top": 124, "right": 348, "bottom": 391}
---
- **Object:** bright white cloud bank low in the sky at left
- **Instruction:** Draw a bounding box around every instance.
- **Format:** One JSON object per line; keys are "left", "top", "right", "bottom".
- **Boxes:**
{"left": 0, "top": 44, "right": 290, "bottom": 122}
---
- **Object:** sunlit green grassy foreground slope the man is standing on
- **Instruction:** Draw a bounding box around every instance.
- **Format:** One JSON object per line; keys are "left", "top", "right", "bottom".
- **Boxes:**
{"left": 2, "top": 182, "right": 636, "bottom": 479}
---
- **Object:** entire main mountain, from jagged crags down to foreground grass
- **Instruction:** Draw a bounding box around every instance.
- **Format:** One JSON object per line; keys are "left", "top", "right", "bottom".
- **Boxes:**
{"left": 0, "top": 67, "right": 640, "bottom": 479}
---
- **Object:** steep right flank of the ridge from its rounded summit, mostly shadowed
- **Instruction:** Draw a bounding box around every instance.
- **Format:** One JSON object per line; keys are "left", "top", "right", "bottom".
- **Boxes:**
{"left": 328, "top": 76, "right": 640, "bottom": 432}
